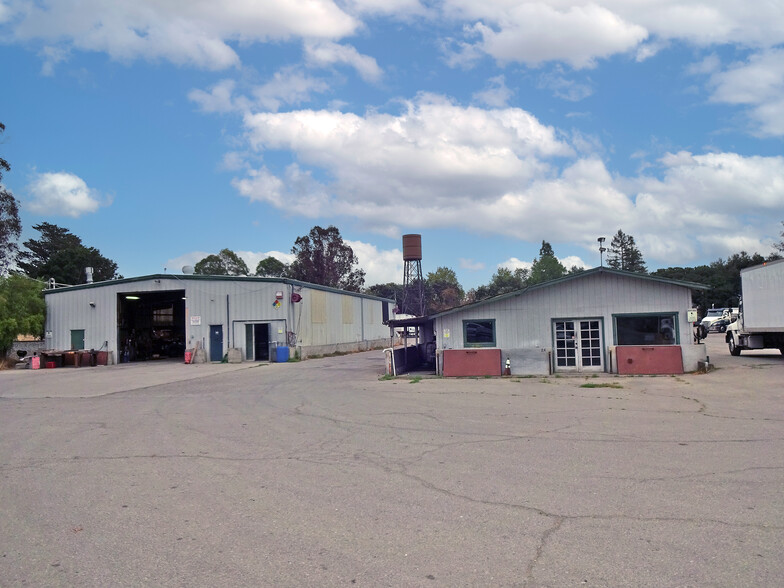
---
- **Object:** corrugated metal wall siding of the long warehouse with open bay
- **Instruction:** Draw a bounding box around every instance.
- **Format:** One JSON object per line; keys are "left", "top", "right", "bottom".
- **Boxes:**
{"left": 46, "top": 277, "right": 393, "bottom": 358}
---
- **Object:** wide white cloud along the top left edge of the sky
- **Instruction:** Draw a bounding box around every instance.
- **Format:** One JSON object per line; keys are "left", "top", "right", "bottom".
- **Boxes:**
{"left": 3, "top": 0, "right": 360, "bottom": 70}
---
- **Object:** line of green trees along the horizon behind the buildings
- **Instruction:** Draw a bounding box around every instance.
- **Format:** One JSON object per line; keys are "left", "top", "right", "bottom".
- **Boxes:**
{"left": 0, "top": 115, "right": 784, "bottom": 359}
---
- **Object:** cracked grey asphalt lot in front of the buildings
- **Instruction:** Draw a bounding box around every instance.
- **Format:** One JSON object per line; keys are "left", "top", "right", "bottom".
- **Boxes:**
{"left": 0, "top": 334, "right": 784, "bottom": 587}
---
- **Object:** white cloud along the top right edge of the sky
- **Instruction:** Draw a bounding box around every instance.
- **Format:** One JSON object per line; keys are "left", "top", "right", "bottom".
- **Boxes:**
{"left": 443, "top": 0, "right": 784, "bottom": 69}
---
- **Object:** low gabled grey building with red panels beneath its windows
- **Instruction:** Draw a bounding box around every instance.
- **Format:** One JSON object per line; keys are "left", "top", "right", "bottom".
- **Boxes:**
{"left": 426, "top": 268, "right": 707, "bottom": 376}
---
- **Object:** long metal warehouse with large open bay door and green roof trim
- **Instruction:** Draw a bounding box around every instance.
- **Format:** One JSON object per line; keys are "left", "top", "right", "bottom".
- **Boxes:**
{"left": 44, "top": 274, "right": 394, "bottom": 363}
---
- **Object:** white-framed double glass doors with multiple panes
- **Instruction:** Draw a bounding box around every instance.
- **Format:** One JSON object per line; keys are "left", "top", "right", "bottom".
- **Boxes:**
{"left": 553, "top": 319, "right": 604, "bottom": 372}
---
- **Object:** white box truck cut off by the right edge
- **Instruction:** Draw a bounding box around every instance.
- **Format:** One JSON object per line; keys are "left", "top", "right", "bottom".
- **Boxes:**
{"left": 725, "top": 259, "right": 784, "bottom": 356}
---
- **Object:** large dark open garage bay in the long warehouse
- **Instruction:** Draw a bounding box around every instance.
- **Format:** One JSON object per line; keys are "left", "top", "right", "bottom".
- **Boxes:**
{"left": 117, "top": 290, "right": 185, "bottom": 363}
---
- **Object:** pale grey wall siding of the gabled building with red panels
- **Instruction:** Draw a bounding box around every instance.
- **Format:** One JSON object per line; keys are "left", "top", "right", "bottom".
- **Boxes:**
{"left": 436, "top": 274, "right": 691, "bottom": 349}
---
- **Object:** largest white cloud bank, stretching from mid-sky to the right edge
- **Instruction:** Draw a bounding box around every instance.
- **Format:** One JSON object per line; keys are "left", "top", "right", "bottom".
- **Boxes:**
{"left": 227, "top": 95, "right": 784, "bottom": 267}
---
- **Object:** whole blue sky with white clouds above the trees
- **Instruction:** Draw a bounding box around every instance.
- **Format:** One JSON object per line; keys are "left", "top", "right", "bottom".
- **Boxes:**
{"left": 0, "top": 0, "right": 784, "bottom": 288}
